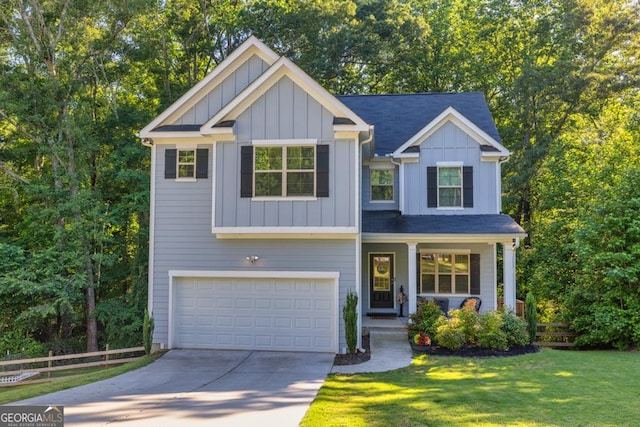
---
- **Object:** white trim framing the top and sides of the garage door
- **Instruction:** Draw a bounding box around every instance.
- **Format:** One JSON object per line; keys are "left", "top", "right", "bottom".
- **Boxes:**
{"left": 167, "top": 270, "right": 340, "bottom": 353}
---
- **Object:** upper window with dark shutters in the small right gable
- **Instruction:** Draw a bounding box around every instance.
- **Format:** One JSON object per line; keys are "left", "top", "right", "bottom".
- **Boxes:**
{"left": 427, "top": 162, "right": 473, "bottom": 209}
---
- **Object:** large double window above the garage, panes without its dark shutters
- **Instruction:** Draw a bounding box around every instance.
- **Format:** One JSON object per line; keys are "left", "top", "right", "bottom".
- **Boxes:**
{"left": 254, "top": 145, "right": 316, "bottom": 197}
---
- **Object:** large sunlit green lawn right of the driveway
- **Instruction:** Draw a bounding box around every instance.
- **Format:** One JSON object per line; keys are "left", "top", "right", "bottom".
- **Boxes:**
{"left": 301, "top": 350, "right": 640, "bottom": 427}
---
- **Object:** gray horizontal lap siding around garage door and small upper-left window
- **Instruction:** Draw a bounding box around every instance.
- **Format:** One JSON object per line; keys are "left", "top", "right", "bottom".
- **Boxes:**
{"left": 152, "top": 145, "right": 357, "bottom": 348}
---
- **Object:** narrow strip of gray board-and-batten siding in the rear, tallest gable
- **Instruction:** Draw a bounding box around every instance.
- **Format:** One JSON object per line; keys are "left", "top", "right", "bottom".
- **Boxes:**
{"left": 173, "top": 55, "right": 269, "bottom": 125}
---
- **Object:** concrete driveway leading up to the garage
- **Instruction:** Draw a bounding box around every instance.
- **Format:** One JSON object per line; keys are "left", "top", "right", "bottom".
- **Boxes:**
{"left": 12, "top": 350, "right": 333, "bottom": 427}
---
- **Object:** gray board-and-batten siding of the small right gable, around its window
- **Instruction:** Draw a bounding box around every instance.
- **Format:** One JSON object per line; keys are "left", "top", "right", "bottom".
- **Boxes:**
{"left": 403, "top": 122, "right": 499, "bottom": 215}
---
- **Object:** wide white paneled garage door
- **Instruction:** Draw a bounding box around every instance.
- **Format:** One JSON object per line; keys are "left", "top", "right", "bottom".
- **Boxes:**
{"left": 173, "top": 277, "right": 338, "bottom": 352}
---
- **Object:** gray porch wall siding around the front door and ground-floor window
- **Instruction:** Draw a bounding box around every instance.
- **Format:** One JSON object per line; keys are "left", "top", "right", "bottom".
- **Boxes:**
{"left": 361, "top": 243, "right": 496, "bottom": 315}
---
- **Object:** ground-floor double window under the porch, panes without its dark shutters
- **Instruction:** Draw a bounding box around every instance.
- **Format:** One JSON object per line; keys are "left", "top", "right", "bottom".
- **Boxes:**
{"left": 419, "top": 252, "right": 471, "bottom": 294}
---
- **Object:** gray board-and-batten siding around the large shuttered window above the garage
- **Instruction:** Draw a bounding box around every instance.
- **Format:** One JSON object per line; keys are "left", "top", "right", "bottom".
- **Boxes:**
{"left": 215, "top": 77, "right": 358, "bottom": 231}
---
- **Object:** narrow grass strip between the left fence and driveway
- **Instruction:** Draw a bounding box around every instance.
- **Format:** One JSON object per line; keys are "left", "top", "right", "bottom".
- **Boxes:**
{"left": 0, "top": 352, "right": 164, "bottom": 405}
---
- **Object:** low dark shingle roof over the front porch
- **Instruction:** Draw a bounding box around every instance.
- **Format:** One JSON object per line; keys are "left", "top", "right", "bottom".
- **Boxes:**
{"left": 362, "top": 211, "right": 525, "bottom": 235}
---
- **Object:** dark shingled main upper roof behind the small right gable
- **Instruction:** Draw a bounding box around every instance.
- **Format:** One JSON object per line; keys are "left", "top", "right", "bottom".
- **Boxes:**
{"left": 337, "top": 92, "right": 501, "bottom": 156}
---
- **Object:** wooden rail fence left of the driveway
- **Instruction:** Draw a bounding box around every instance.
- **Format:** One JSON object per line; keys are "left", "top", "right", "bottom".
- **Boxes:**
{"left": 0, "top": 346, "right": 144, "bottom": 387}
